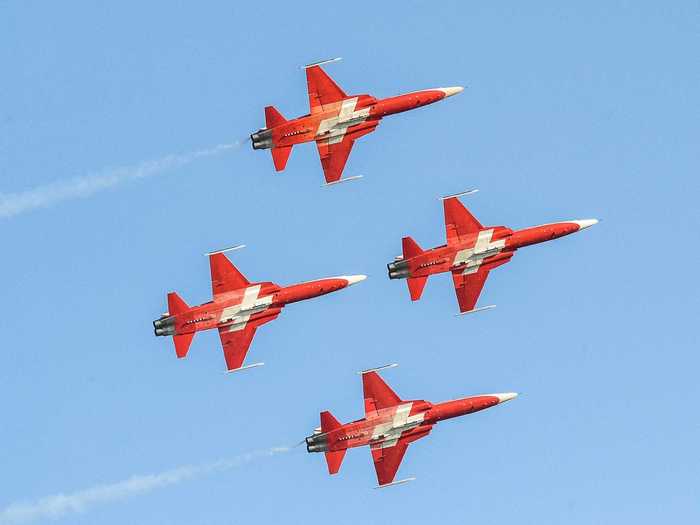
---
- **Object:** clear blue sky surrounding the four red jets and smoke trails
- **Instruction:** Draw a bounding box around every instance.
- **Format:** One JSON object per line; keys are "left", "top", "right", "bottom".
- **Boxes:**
{"left": 0, "top": 1, "right": 700, "bottom": 525}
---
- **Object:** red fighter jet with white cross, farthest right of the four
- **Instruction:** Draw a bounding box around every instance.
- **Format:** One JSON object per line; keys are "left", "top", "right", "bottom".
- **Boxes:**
{"left": 387, "top": 190, "right": 598, "bottom": 314}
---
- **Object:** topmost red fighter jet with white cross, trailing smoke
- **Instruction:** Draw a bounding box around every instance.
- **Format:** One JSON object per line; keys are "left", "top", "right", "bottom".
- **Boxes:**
{"left": 250, "top": 58, "right": 464, "bottom": 184}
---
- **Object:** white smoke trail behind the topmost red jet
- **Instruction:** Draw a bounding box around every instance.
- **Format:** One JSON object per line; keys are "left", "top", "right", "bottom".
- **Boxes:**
{"left": 0, "top": 141, "right": 243, "bottom": 218}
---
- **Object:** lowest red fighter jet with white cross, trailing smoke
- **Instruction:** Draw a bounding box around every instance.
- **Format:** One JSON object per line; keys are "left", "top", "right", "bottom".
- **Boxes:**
{"left": 306, "top": 364, "right": 518, "bottom": 487}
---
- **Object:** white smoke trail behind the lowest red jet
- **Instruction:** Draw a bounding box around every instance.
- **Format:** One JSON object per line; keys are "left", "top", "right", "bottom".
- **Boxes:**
{"left": 0, "top": 447, "right": 291, "bottom": 525}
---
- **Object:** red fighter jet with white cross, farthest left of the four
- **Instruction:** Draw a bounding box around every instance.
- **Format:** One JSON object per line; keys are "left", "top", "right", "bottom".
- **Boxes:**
{"left": 153, "top": 247, "right": 367, "bottom": 372}
